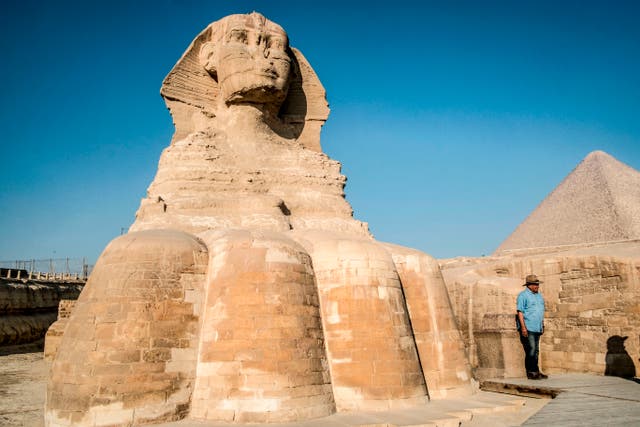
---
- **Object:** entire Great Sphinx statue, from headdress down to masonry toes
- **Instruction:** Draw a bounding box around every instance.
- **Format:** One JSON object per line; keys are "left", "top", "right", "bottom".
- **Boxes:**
{"left": 45, "top": 13, "right": 472, "bottom": 427}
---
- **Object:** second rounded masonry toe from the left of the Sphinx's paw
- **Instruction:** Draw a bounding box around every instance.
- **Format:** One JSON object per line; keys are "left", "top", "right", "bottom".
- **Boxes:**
{"left": 192, "top": 230, "right": 335, "bottom": 422}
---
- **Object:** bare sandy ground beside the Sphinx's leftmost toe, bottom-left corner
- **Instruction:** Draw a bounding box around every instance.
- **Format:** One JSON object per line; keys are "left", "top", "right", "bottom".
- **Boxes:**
{"left": 0, "top": 347, "right": 47, "bottom": 427}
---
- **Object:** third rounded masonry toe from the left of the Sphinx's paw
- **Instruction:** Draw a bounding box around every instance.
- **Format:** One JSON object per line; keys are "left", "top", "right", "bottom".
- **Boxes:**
{"left": 296, "top": 233, "right": 426, "bottom": 411}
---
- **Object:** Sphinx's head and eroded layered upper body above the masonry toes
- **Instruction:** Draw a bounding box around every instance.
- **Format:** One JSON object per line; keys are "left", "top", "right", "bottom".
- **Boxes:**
{"left": 131, "top": 13, "right": 369, "bottom": 236}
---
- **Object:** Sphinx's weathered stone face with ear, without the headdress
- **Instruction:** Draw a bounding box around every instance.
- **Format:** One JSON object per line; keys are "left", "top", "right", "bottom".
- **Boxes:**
{"left": 199, "top": 12, "right": 291, "bottom": 106}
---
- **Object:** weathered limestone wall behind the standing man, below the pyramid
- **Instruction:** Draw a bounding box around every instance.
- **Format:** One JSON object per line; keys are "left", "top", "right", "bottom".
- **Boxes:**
{"left": 443, "top": 241, "right": 640, "bottom": 378}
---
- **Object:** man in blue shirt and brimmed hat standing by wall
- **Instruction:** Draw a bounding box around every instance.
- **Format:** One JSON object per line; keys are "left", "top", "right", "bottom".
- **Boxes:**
{"left": 517, "top": 274, "right": 548, "bottom": 380}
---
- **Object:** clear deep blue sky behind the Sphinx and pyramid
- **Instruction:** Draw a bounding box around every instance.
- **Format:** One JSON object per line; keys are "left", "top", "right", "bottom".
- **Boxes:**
{"left": 0, "top": 0, "right": 640, "bottom": 261}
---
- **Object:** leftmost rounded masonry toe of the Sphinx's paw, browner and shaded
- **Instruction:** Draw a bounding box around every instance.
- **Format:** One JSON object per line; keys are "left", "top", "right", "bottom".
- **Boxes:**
{"left": 45, "top": 231, "right": 207, "bottom": 426}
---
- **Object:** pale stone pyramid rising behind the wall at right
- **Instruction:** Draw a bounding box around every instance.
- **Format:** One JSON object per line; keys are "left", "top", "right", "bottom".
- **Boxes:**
{"left": 494, "top": 151, "right": 640, "bottom": 255}
